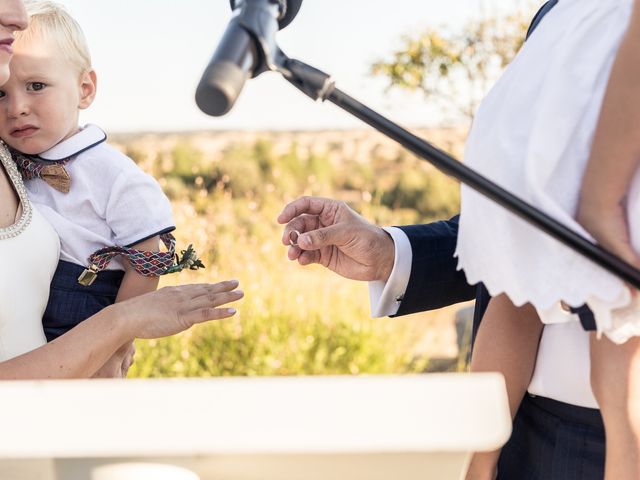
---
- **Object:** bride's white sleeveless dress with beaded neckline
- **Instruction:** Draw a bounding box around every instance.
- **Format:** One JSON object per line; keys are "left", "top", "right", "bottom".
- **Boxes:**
{"left": 0, "top": 144, "right": 60, "bottom": 361}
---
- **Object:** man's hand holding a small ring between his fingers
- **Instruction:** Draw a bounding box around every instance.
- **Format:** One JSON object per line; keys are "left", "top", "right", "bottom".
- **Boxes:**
{"left": 278, "top": 197, "right": 395, "bottom": 281}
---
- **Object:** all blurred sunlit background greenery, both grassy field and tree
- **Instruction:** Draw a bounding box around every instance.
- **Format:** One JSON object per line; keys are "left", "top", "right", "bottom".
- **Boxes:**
{"left": 120, "top": 6, "right": 528, "bottom": 377}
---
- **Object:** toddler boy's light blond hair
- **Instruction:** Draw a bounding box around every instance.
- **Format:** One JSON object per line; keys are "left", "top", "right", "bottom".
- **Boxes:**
{"left": 16, "top": 0, "right": 91, "bottom": 72}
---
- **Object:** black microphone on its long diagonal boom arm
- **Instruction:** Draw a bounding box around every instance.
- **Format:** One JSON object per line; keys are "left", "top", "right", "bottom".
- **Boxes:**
{"left": 196, "top": 0, "right": 640, "bottom": 289}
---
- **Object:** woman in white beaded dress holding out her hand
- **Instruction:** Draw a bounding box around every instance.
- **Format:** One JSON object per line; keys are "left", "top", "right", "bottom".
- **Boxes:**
{"left": 0, "top": 0, "right": 243, "bottom": 379}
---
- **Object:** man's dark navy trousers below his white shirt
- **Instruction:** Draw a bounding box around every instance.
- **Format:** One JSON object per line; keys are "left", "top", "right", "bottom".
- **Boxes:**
{"left": 498, "top": 394, "right": 605, "bottom": 480}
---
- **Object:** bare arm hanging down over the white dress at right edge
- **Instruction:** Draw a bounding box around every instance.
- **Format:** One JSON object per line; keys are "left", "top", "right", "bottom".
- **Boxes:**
{"left": 577, "top": 0, "right": 640, "bottom": 265}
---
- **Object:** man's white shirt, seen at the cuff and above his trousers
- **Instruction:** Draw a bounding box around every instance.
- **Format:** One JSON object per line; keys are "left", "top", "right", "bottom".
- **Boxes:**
{"left": 369, "top": 227, "right": 598, "bottom": 408}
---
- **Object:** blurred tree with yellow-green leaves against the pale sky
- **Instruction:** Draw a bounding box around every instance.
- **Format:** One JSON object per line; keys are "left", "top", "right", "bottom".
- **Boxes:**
{"left": 371, "top": 15, "right": 528, "bottom": 123}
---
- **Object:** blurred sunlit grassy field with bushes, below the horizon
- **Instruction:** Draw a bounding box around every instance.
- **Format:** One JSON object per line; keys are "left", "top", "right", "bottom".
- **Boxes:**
{"left": 126, "top": 128, "right": 459, "bottom": 377}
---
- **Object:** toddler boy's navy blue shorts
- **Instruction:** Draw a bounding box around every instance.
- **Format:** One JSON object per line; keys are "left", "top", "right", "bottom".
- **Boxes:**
{"left": 42, "top": 261, "right": 124, "bottom": 342}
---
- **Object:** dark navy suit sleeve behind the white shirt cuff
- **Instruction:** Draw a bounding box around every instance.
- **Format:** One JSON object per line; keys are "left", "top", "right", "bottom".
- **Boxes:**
{"left": 396, "top": 216, "right": 476, "bottom": 316}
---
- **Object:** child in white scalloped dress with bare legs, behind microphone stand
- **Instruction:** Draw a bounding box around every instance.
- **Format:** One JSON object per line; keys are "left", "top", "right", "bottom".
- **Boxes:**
{"left": 456, "top": 0, "right": 640, "bottom": 479}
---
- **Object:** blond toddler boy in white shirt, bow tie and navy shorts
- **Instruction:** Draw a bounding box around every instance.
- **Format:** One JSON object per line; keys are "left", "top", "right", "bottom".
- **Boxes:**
{"left": 0, "top": 0, "right": 201, "bottom": 377}
